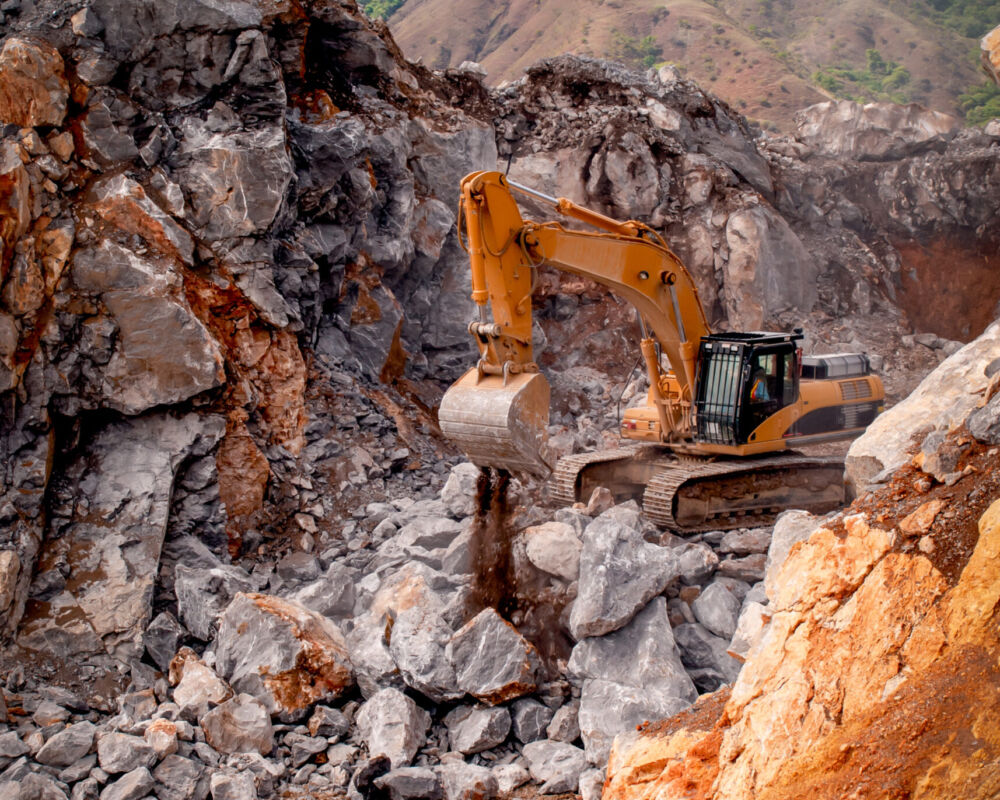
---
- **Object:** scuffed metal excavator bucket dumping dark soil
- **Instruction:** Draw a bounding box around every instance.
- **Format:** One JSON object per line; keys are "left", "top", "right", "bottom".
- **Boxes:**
{"left": 438, "top": 369, "right": 552, "bottom": 478}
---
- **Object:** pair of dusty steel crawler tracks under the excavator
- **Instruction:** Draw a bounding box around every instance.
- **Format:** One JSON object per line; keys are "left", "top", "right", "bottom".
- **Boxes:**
{"left": 551, "top": 446, "right": 844, "bottom": 533}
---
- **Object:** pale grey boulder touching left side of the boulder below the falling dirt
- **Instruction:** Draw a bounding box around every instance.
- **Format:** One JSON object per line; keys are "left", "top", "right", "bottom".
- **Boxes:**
{"left": 389, "top": 605, "right": 465, "bottom": 703}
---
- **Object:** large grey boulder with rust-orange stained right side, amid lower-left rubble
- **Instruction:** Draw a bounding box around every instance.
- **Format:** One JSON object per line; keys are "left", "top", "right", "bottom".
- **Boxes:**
{"left": 215, "top": 592, "right": 353, "bottom": 715}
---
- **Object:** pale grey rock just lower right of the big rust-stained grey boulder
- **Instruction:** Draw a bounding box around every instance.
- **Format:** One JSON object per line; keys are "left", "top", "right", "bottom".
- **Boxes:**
{"left": 356, "top": 689, "right": 430, "bottom": 769}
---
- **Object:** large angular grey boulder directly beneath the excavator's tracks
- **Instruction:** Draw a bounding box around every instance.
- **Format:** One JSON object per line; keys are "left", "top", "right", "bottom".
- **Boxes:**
{"left": 570, "top": 504, "right": 680, "bottom": 640}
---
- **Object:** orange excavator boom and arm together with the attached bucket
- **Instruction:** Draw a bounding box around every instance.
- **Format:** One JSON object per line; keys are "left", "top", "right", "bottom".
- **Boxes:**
{"left": 439, "top": 172, "right": 710, "bottom": 475}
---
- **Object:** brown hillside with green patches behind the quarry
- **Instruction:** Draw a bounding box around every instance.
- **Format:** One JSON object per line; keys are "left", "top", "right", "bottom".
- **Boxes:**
{"left": 380, "top": 0, "right": 1000, "bottom": 129}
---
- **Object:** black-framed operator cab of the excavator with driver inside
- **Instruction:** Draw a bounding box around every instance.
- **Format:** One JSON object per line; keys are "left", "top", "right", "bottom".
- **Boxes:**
{"left": 695, "top": 331, "right": 802, "bottom": 445}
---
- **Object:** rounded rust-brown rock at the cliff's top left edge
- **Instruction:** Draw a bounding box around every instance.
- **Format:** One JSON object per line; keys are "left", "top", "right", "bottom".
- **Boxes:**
{"left": 0, "top": 36, "right": 69, "bottom": 128}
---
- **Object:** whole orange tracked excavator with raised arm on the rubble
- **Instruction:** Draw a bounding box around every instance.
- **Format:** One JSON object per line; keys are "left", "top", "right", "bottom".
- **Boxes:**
{"left": 438, "top": 172, "right": 885, "bottom": 532}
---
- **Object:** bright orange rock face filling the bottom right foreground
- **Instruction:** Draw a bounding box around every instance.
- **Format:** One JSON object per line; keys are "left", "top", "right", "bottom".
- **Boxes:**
{"left": 604, "top": 500, "right": 1000, "bottom": 800}
